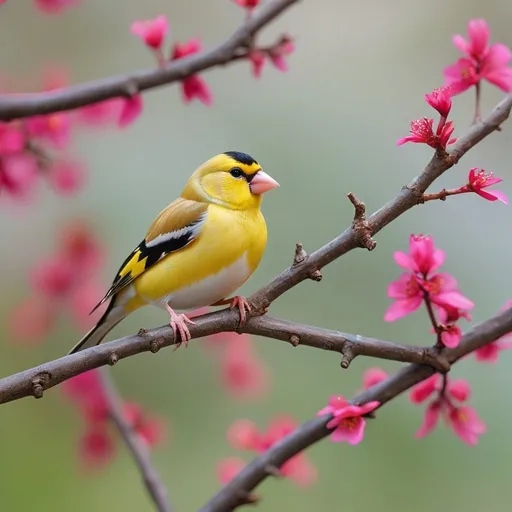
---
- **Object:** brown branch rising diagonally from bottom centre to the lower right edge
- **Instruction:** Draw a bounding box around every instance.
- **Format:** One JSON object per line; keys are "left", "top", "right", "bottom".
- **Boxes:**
{"left": 200, "top": 309, "right": 512, "bottom": 512}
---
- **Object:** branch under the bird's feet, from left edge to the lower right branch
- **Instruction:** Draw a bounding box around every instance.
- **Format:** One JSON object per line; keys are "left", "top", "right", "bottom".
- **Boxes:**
{"left": 0, "top": 309, "right": 450, "bottom": 404}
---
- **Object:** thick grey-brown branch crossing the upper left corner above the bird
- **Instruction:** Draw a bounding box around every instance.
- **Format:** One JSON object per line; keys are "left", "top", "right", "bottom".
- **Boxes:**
{"left": 0, "top": 0, "right": 298, "bottom": 121}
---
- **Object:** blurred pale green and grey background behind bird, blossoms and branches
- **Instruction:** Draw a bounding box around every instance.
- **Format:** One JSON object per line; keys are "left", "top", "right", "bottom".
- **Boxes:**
{"left": 0, "top": 0, "right": 512, "bottom": 512}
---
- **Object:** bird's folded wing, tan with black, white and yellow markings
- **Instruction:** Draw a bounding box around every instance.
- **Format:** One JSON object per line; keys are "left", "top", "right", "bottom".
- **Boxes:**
{"left": 93, "top": 198, "right": 208, "bottom": 311}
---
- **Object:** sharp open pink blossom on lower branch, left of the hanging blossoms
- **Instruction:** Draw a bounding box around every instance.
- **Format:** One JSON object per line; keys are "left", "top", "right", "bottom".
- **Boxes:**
{"left": 317, "top": 395, "right": 380, "bottom": 445}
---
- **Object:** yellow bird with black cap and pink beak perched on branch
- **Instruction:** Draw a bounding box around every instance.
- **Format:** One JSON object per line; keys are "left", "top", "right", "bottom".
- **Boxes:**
{"left": 69, "top": 151, "right": 279, "bottom": 354}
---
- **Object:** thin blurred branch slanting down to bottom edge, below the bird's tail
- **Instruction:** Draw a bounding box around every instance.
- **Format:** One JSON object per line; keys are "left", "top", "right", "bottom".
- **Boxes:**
{"left": 100, "top": 368, "right": 172, "bottom": 512}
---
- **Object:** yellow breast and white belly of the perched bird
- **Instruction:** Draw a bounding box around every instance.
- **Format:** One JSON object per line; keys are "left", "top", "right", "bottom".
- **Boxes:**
{"left": 134, "top": 206, "right": 267, "bottom": 310}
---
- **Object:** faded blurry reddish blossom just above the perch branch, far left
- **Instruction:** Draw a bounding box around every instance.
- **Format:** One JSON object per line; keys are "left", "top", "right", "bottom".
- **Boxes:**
{"left": 9, "top": 297, "right": 55, "bottom": 345}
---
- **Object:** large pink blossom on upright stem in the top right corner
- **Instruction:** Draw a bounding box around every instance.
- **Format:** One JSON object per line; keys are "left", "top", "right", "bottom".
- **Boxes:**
{"left": 444, "top": 19, "right": 512, "bottom": 95}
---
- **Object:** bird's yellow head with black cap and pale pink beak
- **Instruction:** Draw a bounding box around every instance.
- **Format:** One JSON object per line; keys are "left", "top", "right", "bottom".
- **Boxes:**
{"left": 181, "top": 151, "right": 279, "bottom": 210}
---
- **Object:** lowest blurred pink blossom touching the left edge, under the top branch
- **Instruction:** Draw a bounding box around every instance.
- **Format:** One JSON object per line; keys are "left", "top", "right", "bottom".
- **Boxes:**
{"left": 0, "top": 153, "right": 38, "bottom": 200}
